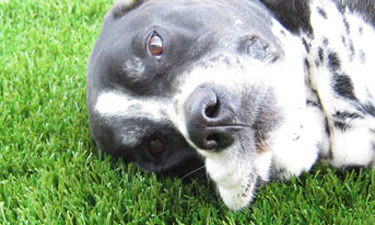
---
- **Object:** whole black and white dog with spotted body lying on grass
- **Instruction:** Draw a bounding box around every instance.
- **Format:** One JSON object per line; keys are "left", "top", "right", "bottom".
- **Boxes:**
{"left": 87, "top": 0, "right": 375, "bottom": 209}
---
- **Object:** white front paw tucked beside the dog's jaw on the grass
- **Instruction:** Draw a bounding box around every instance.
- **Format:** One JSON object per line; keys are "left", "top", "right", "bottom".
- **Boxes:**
{"left": 273, "top": 103, "right": 328, "bottom": 179}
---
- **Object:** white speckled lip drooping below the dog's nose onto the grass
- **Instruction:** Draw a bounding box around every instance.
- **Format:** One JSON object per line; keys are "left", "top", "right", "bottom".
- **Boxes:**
{"left": 198, "top": 138, "right": 272, "bottom": 210}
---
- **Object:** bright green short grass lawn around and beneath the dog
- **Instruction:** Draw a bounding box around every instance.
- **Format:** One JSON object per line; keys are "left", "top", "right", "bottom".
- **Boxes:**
{"left": 0, "top": 0, "right": 375, "bottom": 224}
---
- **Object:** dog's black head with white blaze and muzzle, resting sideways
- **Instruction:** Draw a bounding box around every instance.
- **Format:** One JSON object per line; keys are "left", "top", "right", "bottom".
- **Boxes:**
{"left": 87, "top": 0, "right": 305, "bottom": 209}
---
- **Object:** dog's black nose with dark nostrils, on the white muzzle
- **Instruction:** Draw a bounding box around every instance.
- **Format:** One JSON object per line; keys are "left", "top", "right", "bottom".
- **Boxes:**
{"left": 185, "top": 87, "right": 239, "bottom": 150}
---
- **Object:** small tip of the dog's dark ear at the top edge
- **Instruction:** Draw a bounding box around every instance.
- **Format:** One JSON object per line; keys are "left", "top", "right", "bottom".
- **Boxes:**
{"left": 105, "top": 0, "right": 147, "bottom": 20}
